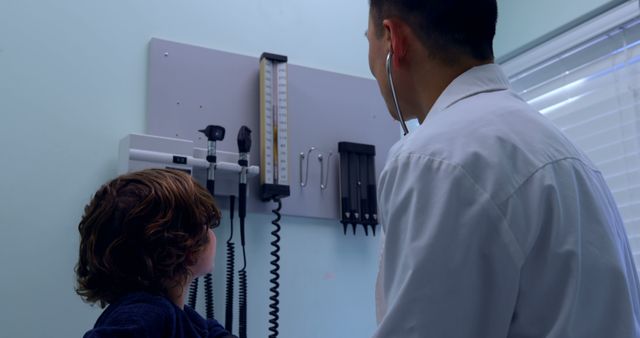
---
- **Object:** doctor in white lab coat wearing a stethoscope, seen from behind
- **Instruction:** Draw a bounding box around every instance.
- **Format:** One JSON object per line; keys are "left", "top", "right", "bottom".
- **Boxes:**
{"left": 367, "top": 0, "right": 640, "bottom": 338}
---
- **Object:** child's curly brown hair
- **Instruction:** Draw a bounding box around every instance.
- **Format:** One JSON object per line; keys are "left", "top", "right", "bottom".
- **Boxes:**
{"left": 75, "top": 169, "right": 220, "bottom": 307}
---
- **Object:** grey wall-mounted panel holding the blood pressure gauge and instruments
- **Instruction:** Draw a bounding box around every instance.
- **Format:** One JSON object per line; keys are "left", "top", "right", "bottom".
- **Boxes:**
{"left": 147, "top": 39, "right": 400, "bottom": 220}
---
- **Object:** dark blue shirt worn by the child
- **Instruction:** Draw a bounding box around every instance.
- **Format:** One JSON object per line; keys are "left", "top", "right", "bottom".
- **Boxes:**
{"left": 84, "top": 292, "right": 234, "bottom": 338}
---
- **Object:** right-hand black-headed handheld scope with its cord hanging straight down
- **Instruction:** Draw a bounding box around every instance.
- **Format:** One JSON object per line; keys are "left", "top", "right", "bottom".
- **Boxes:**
{"left": 238, "top": 126, "right": 251, "bottom": 338}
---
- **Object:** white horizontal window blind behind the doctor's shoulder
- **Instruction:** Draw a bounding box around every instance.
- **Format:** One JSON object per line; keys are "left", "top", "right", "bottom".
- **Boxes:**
{"left": 507, "top": 18, "right": 640, "bottom": 268}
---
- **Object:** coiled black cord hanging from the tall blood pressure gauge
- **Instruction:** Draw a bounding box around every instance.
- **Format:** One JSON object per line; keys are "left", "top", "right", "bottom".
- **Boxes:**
{"left": 269, "top": 199, "right": 282, "bottom": 338}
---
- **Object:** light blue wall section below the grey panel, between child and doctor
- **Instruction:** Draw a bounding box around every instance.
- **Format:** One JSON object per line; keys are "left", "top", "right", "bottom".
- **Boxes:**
{"left": 210, "top": 213, "right": 378, "bottom": 338}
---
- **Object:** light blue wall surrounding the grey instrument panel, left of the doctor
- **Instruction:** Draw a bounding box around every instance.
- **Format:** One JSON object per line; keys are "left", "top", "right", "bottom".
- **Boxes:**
{"left": 0, "top": 0, "right": 377, "bottom": 337}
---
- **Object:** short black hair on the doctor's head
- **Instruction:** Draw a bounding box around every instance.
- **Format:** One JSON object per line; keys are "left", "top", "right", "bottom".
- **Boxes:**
{"left": 369, "top": 0, "right": 498, "bottom": 64}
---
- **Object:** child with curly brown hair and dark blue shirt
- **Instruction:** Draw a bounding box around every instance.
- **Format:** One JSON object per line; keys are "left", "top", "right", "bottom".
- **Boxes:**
{"left": 76, "top": 169, "right": 233, "bottom": 338}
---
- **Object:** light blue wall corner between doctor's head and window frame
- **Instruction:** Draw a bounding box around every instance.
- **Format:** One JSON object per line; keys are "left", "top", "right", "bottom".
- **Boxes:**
{"left": 495, "top": 0, "right": 624, "bottom": 58}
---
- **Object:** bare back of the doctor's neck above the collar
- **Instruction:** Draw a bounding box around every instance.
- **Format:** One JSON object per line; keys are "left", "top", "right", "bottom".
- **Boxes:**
{"left": 406, "top": 49, "right": 493, "bottom": 124}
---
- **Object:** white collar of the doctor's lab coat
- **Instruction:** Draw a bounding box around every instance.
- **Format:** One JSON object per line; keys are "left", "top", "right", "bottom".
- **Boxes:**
{"left": 425, "top": 63, "right": 511, "bottom": 121}
